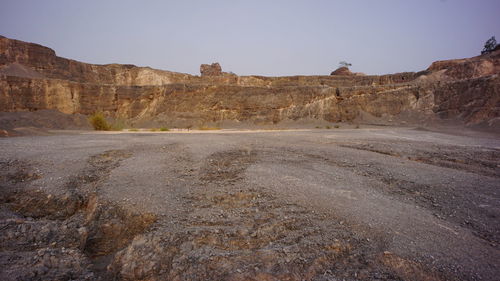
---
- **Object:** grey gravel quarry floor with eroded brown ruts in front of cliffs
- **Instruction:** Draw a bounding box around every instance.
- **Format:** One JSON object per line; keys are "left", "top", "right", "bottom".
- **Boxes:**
{"left": 0, "top": 127, "right": 500, "bottom": 280}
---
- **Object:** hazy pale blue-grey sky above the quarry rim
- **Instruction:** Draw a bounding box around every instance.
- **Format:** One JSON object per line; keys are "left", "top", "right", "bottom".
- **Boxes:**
{"left": 0, "top": 0, "right": 500, "bottom": 76}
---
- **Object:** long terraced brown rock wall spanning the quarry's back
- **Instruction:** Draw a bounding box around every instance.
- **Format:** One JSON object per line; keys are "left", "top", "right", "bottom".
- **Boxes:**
{"left": 0, "top": 35, "right": 500, "bottom": 126}
